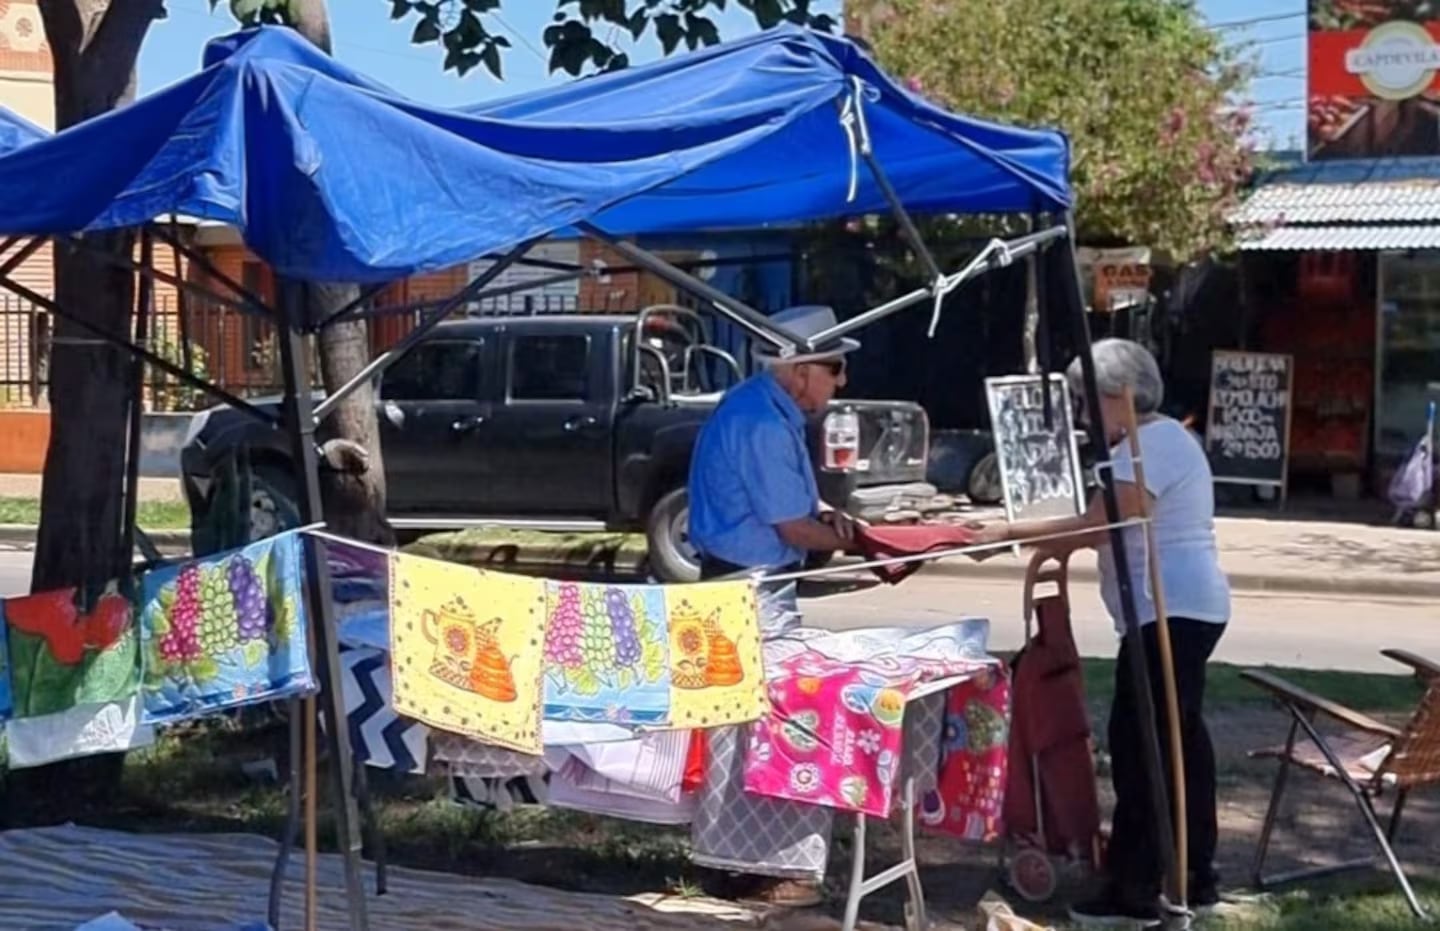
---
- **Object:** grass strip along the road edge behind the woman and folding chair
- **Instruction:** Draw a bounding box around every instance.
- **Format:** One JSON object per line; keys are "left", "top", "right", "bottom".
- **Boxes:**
{"left": 1080, "top": 658, "right": 1423, "bottom": 712}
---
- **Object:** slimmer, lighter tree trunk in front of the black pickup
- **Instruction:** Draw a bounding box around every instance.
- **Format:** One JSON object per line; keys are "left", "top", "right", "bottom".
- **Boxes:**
{"left": 288, "top": 0, "right": 395, "bottom": 545}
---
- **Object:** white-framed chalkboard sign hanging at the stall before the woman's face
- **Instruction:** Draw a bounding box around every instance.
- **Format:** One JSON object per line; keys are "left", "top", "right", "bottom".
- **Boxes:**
{"left": 985, "top": 376, "right": 1084, "bottom": 521}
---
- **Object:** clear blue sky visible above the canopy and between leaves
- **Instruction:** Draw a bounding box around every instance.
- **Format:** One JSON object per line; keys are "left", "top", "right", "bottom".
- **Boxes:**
{"left": 140, "top": 0, "right": 1305, "bottom": 147}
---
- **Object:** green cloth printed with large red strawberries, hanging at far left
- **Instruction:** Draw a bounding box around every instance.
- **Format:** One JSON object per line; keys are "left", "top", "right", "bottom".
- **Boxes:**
{"left": 0, "top": 584, "right": 140, "bottom": 718}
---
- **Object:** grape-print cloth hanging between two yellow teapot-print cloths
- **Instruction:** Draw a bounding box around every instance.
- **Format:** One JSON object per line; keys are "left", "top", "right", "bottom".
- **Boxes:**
{"left": 544, "top": 581, "right": 670, "bottom": 727}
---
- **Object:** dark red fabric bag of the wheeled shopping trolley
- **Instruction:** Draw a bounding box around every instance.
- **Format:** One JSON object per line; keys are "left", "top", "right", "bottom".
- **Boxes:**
{"left": 1004, "top": 596, "right": 1100, "bottom": 865}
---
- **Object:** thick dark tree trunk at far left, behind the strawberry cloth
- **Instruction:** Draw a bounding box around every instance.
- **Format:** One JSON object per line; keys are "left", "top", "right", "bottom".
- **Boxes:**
{"left": 7, "top": 0, "right": 163, "bottom": 823}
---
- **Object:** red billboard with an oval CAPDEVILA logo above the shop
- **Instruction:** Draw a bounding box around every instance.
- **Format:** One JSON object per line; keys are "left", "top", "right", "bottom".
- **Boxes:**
{"left": 1306, "top": 0, "right": 1440, "bottom": 160}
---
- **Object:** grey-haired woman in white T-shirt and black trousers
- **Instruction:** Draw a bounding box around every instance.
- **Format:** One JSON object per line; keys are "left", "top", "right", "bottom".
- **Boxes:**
{"left": 981, "top": 340, "right": 1230, "bottom": 924}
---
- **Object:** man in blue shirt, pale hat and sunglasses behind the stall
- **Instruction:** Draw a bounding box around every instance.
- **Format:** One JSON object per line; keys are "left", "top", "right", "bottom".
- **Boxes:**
{"left": 690, "top": 306, "right": 860, "bottom": 908}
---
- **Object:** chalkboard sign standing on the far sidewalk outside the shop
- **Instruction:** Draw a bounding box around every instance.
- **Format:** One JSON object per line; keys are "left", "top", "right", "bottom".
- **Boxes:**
{"left": 1205, "top": 351, "right": 1295, "bottom": 496}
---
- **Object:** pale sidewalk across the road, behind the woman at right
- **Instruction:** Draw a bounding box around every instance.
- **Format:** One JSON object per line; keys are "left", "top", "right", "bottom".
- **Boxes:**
{"left": 929, "top": 518, "right": 1440, "bottom": 599}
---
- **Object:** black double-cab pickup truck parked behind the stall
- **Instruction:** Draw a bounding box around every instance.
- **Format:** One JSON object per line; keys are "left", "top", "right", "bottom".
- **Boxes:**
{"left": 180, "top": 306, "right": 936, "bottom": 581}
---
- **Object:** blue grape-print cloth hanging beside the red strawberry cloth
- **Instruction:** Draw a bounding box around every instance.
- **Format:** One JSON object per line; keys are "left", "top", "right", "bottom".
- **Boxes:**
{"left": 140, "top": 532, "right": 314, "bottom": 724}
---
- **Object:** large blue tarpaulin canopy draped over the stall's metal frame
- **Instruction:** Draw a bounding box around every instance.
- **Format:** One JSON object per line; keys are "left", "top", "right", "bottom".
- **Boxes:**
{"left": 0, "top": 27, "right": 1070, "bottom": 290}
